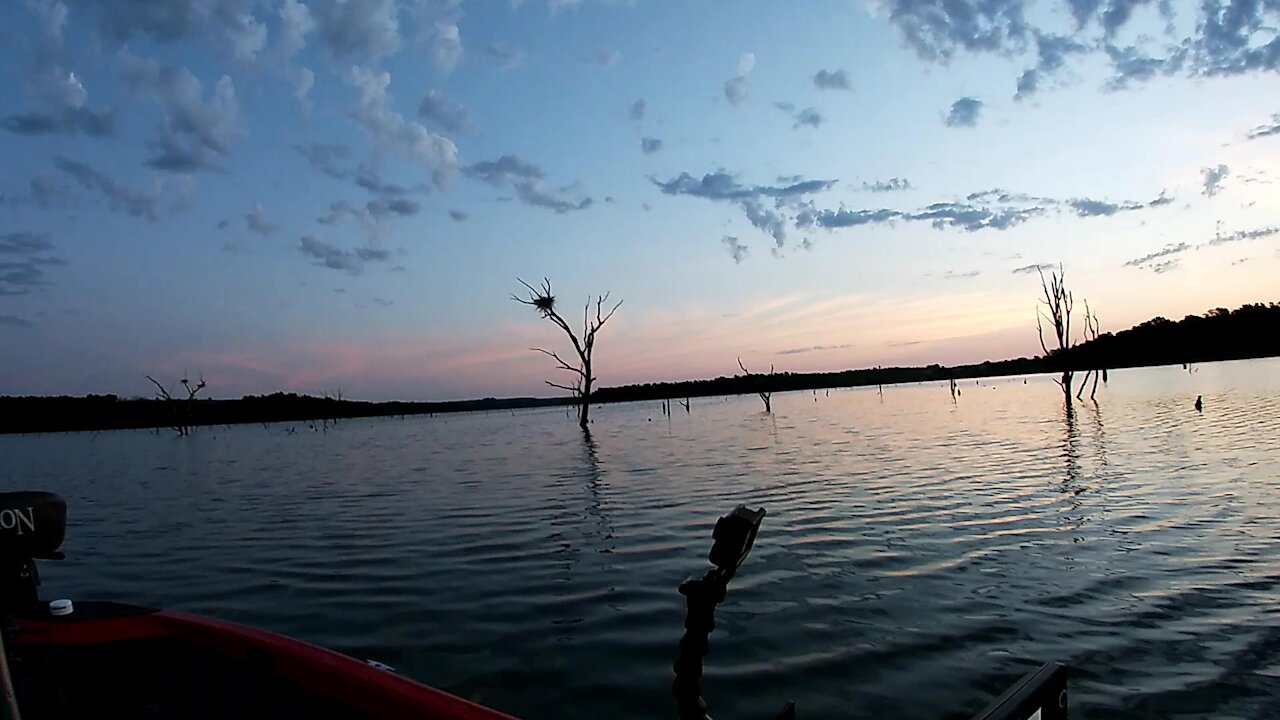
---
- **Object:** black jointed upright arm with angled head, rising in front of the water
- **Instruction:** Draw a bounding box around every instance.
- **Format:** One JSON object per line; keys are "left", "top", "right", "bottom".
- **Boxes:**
{"left": 671, "top": 505, "right": 795, "bottom": 720}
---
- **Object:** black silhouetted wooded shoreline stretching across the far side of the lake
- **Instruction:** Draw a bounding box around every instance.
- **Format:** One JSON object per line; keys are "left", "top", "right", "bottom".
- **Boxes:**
{"left": 0, "top": 302, "right": 1280, "bottom": 433}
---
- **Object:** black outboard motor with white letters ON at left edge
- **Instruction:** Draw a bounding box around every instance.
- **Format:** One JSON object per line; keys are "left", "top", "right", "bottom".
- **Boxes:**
{"left": 0, "top": 492, "right": 67, "bottom": 616}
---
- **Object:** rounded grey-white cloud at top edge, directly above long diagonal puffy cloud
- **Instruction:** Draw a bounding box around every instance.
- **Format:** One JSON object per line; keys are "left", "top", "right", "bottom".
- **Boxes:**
{"left": 308, "top": 0, "right": 401, "bottom": 61}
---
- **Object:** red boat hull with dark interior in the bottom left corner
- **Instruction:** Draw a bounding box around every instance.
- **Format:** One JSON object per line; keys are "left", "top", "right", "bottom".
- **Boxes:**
{"left": 10, "top": 602, "right": 512, "bottom": 720}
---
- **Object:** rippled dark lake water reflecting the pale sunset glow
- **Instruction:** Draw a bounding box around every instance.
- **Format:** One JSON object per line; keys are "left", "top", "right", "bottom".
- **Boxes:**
{"left": 0, "top": 360, "right": 1280, "bottom": 720}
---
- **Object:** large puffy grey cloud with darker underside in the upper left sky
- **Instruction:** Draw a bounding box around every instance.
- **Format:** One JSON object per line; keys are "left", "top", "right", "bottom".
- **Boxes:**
{"left": 120, "top": 50, "right": 241, "bottom": 173}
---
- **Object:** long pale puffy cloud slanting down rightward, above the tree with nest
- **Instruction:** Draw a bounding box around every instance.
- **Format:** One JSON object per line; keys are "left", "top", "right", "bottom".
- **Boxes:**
{"left": 347, "top": 65, "right": 458, "bottom": 188}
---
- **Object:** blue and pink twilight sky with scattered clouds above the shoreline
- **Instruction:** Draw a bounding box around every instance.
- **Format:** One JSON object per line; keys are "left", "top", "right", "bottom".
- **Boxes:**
{"left": 0, "top": 0, "right": 1280, "bottom": 400}
